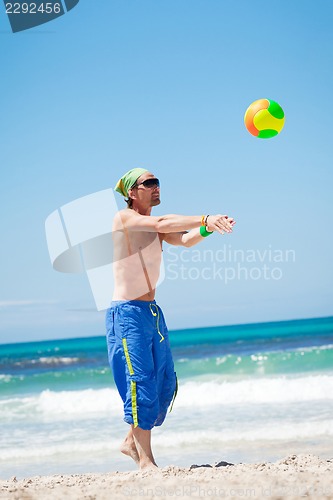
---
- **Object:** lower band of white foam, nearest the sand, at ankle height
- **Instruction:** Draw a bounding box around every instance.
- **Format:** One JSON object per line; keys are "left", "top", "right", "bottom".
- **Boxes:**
{"left": 0, "top": 420, "right": 333, "bottom": 463}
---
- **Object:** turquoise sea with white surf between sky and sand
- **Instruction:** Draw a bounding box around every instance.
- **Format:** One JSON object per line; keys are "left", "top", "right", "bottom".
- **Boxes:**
{"left": 0, "top": 317, "right": 333, "bottom": 479}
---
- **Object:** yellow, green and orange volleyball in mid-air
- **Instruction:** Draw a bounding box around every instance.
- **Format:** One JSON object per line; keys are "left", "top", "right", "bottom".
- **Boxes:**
{"left": 244, "top": 99, "right": 284, "bottom": 139}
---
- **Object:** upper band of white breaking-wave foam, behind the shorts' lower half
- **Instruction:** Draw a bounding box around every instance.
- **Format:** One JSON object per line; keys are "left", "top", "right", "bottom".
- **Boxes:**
{"left": 0, "top": 374, "right": 333, "bottom": 420}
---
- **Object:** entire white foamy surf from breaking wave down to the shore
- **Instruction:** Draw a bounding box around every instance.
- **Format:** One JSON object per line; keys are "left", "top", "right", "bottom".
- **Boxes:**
{"left": 0, "top": 374, "right": 333, "bottom": 462}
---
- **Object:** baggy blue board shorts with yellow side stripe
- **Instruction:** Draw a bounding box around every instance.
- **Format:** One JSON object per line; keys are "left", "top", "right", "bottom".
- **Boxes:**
{"left": 106, "top": 300, "right": 177, "bottom": 430}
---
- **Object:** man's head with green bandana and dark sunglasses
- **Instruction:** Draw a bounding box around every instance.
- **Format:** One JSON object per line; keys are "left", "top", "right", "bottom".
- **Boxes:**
{"left": 115, "top": 168, "right": 161, "bottom": 208}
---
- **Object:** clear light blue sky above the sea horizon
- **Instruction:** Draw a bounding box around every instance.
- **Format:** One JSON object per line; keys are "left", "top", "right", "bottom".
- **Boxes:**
{"left": 0, "top": 0, "right": 333, "bottom": 342}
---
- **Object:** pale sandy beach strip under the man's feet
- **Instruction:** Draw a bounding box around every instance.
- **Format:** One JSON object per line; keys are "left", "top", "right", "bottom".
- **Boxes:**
{"left": 0, "top": 455, "right": 333, "bottom": 500}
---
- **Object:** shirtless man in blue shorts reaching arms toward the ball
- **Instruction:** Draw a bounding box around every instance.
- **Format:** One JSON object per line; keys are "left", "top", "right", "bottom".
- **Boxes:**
{"left": 106, "top": 168, "right": 235, "bottom": 469}
